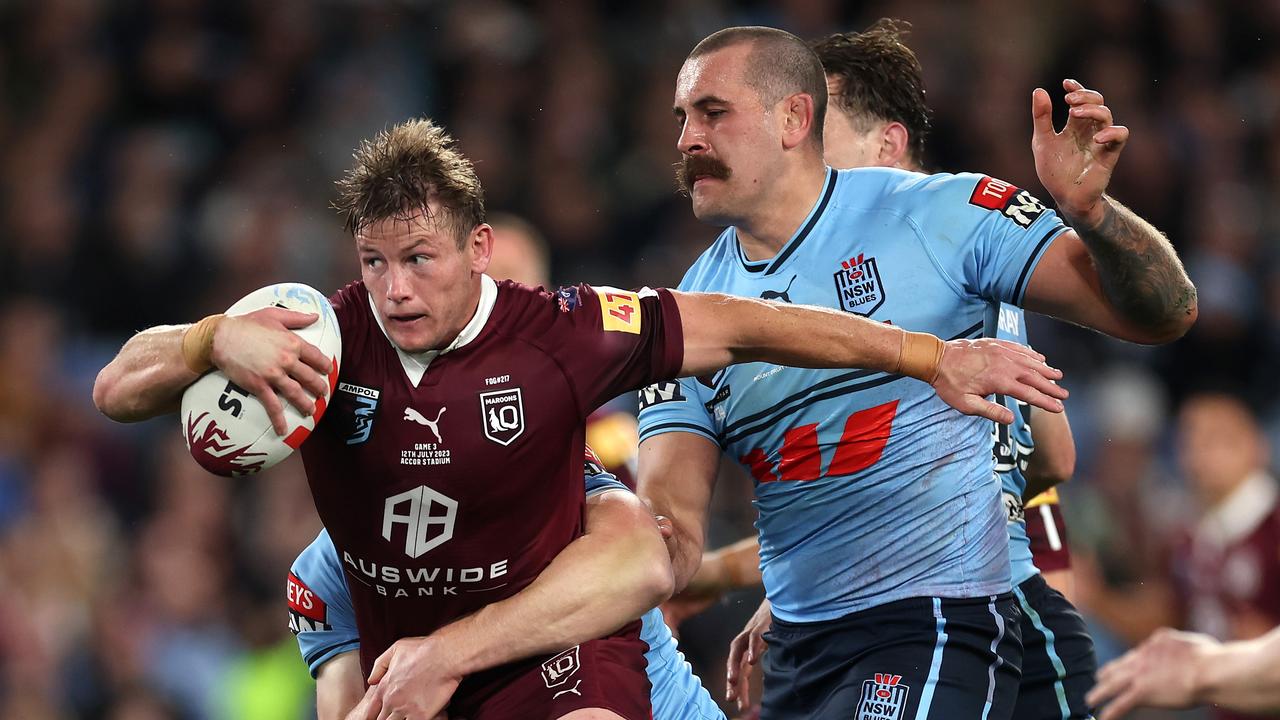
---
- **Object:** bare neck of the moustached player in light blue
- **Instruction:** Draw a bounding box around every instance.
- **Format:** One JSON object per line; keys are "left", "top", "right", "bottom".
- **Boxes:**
{"left": 733, "top": 163, "right": 827, "bottom": 261}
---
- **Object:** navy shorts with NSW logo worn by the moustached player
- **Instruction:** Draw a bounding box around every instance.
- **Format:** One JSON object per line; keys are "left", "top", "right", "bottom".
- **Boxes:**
{"left": 760, "top": 593, "right": 1021, "bottom": 720}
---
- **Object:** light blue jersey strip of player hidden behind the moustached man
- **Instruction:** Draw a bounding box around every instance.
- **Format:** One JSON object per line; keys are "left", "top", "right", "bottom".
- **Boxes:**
{"left": 987, "top": 304, "right": 1039, "bottom": 585}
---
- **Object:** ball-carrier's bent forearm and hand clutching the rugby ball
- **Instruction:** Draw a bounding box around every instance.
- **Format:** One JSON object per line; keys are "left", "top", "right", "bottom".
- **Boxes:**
{"left": 93, "top": 307, "right": 330, "bottom": 436}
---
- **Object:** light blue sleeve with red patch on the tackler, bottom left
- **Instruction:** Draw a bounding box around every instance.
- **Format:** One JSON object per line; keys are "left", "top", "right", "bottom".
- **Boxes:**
{"left": 285, "top": 530, "right": 360, "bottom": 678}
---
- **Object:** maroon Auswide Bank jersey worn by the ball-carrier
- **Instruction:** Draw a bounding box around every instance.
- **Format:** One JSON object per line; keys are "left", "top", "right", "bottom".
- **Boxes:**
{"left": 302, "top": 277, "right": 684, "bottom": 673}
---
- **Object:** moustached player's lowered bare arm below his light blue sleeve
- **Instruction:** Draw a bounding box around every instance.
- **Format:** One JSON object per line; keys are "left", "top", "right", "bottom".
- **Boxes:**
{"left": 636, "top": 433, "right": 721, "bottom": 592}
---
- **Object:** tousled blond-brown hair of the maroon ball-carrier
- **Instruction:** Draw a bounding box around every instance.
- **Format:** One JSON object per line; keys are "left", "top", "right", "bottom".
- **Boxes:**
{"left": 333, "top": 118, "right": 484, "bottom": 249}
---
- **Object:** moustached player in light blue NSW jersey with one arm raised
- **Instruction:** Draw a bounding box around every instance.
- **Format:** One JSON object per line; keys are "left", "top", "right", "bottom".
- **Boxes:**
{"left": 640, "top": 23, "right": 1196, "bottom": 717}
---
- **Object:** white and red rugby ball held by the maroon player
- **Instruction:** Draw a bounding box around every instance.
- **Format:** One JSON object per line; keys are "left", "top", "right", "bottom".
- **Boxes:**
{"left": 179, "top": 283, "right": 342, "bottom": 477}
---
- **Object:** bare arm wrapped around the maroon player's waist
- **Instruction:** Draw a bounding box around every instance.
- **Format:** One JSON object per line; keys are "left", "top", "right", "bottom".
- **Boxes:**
{"left": 357, "top": 489, "right": 672, "bottom": 720}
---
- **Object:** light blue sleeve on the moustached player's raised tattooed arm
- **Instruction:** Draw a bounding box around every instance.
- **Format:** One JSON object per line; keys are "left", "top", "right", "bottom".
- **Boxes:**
{"left": 911, "top": 173, "right": 1068, "bottom": 306}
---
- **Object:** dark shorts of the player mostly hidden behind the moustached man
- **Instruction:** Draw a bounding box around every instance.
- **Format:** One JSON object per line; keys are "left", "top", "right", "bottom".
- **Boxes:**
{"left": 1014, "top": 575, "right": 1098, "bottom": 720}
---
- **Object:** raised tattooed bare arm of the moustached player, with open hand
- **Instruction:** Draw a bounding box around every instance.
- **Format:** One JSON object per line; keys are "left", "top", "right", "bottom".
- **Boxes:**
{"left": 1024, "top": 79, "right": 1198, "bottom": 345}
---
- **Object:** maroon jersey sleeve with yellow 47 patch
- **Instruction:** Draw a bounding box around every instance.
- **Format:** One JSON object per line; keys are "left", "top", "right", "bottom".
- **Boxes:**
{"left": 540, "top": 284, "right": 685, "bottom": 418}
